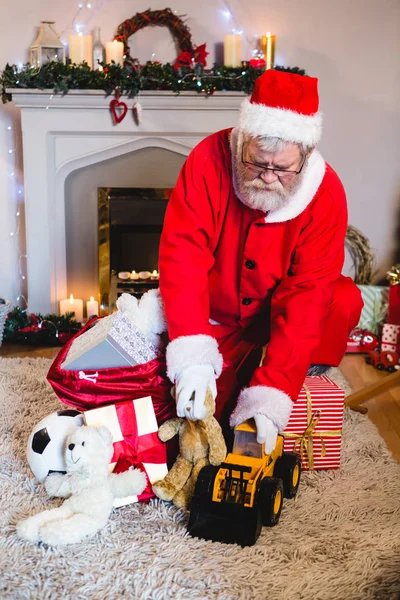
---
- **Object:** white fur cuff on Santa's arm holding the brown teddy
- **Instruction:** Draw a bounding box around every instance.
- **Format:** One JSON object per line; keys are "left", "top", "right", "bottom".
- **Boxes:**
{"left": 166, "top": 334, "right": 223, "bottom": 383}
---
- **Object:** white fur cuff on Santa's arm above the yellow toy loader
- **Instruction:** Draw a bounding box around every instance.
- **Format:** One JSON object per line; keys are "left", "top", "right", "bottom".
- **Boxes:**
{"left": 230, "top": 385, "right": 293, "bottom": 431}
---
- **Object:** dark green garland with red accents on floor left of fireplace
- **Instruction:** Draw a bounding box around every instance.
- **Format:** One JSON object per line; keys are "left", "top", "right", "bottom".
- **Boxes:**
{"left": 3, "top": 307, "right": 82, "bottom": 346}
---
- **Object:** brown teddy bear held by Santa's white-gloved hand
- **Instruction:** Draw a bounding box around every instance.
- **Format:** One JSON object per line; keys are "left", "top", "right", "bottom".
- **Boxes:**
{"left": 153, "top": 390, "right": 227, "bottom": 509}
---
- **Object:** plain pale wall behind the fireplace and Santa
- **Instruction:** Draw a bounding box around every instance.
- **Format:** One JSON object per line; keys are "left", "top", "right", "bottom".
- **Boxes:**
{"left": 0, "top": 0, "right": 400, "bottom": 302}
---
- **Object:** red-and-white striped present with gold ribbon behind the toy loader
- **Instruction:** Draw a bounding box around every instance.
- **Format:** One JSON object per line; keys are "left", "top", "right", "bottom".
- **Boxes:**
{"left": 282, "top": 376, "right": 344, "bottom": 470}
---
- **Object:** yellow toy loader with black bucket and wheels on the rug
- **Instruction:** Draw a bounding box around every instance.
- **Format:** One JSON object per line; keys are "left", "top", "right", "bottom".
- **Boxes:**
{"left": 188, "top": 419, "right": 301, "bottom": 546}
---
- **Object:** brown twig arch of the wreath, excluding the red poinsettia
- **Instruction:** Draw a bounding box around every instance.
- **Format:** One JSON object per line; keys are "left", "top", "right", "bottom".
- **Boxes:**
{"left": 114, "top": 8, "right": 195, "bottom": 65}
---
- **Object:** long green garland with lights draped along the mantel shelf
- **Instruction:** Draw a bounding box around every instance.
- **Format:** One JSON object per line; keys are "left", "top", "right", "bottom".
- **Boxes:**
{"left": 0, "top": 62, "right": 305, "bottom": 103}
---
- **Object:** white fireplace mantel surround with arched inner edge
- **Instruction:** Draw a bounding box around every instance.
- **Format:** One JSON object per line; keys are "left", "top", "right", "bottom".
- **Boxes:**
{"left": 7, "top": 89, "right": 246, "bottom": 313}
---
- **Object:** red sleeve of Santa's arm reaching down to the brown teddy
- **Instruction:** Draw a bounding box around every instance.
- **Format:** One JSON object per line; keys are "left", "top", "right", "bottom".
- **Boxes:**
{"left": 159, "top": 138, "right": 220, "bottom": 340}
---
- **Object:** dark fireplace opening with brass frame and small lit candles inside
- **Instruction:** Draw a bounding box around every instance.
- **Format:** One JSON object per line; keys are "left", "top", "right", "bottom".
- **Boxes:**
{"left": 98, "top": 187, "right": 172, "bottom": 315}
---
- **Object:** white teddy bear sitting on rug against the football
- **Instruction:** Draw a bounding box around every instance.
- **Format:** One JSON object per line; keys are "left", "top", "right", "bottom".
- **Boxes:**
{"left": 17, "top": 426, "right": 147, "bottom": 546}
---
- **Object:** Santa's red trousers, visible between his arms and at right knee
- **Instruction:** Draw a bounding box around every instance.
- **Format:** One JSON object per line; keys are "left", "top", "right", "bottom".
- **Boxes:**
{"left": 212, "top": 276, "right": 363, "bottom": 418}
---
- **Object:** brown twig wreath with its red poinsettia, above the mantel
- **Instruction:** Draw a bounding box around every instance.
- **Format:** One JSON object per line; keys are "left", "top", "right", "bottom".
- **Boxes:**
{"left": 114, "top": 8, "right": 208, "bottom": 69}
